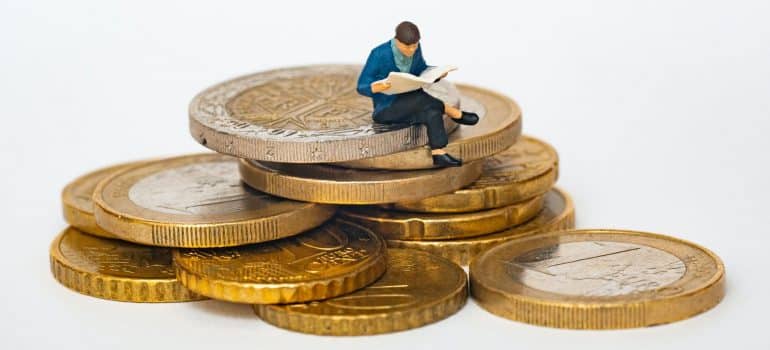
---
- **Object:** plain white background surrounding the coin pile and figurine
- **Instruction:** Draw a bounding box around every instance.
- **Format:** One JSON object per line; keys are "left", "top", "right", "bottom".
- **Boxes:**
{"left": 0, "top": 0, "right": 770, "bottom": 349}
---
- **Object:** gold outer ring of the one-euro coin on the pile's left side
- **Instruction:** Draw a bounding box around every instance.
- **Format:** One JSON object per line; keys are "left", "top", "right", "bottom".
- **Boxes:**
{"left": 93, "top": 153, "right": 336, "bottom": 248}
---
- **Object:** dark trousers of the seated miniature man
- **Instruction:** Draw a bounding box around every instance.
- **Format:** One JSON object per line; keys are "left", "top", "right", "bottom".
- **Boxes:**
{"left": 372, "top": 89, "right": 448, "bottom": 149}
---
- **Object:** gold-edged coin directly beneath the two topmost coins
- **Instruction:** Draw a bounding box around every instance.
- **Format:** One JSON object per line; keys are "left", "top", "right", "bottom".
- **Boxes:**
{"left": 240, "top": 159, "right": 483, "bottom": 204}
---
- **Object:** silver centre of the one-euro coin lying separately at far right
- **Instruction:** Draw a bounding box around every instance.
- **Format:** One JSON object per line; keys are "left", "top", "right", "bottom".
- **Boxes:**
{"left": 503, "top": 241, "right": 686, "bottom": 297}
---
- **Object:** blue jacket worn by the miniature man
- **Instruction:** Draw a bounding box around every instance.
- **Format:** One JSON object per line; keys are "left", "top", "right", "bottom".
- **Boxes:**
{"left": 357, "top": 40, "right": 428, "bottom": 114}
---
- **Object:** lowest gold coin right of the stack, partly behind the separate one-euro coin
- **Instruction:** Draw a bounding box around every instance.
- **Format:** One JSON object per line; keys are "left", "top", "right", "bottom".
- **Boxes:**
{"left": 388, "top": 188, "right": 575, "bottom": 266}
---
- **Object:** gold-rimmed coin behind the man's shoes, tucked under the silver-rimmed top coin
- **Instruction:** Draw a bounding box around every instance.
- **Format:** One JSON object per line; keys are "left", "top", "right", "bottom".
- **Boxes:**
{"left": 339, "top": 85, "right": 521, "bottom": 170}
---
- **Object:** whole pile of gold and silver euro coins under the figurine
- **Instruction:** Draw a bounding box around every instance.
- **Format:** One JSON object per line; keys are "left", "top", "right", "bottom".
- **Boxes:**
{"left": 51, "top": 65, "right": 724, "bottom": 335}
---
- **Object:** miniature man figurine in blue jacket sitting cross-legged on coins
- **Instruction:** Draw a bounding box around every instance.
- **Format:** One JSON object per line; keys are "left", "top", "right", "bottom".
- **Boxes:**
{"left": 358, "top": 22, "right": 479, "bottom": 167}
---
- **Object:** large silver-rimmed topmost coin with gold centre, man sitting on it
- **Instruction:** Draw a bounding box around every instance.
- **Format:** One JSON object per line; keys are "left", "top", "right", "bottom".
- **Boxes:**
{"left": 189, "top": 65, "right": 459, "bottom": 163}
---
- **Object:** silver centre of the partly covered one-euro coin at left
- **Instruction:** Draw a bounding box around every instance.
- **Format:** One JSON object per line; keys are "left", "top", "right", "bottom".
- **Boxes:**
{"left": 128, "top": 161, "right": 258, "bottom": 215}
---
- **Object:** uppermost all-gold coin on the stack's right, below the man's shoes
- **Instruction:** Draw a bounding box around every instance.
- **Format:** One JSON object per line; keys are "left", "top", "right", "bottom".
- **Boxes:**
{"left": 384, "top": 136, "right": 559, "bottom": 213}
